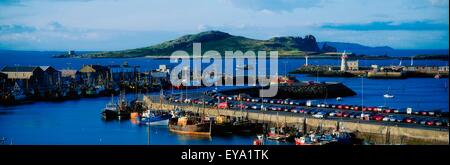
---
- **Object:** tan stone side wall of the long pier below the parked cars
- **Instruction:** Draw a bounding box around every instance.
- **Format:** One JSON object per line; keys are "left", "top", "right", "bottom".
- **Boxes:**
{"left": 144, "top": 96, "right": 449, "bottom": 145}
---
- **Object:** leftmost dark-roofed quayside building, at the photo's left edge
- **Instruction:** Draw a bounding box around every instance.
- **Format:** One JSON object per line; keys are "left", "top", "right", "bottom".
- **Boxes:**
{"left": 1, "top": 66, "right": 45, "bottom": 91}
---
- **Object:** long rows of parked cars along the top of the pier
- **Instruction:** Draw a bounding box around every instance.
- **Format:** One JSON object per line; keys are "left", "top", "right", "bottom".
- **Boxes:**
{"left": 166, "top": 95, "right": 449, "bottom": 126}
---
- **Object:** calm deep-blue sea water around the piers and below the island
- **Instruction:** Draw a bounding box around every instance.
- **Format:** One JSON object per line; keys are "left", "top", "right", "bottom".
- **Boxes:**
{"left": 0, "top": 51, "right": 449, "bottom": 145}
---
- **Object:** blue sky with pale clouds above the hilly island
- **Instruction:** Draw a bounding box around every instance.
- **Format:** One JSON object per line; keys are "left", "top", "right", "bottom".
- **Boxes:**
{"left": 0, "top": 0, "right": 449, "bottom": 50}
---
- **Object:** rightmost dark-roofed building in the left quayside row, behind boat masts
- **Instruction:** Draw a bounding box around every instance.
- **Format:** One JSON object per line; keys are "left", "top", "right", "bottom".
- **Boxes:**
{"left": 78, "top": 65, "right": 110, "bottom": 85}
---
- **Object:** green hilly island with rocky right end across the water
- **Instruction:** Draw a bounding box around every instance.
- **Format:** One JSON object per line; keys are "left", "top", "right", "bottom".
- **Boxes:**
{"left": 56, "top": 31, "right": 321, "bottom": 58}
